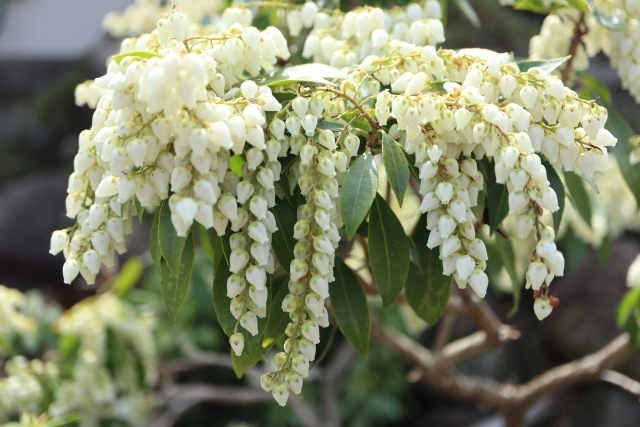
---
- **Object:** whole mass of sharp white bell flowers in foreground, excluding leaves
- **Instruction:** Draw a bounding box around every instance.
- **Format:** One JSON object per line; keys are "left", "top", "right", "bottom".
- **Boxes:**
{"left": 56, "top": 0, "right": 616, "bottom": 405}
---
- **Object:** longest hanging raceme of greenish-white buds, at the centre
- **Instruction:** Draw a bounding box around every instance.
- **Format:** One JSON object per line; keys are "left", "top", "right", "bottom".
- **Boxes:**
{"left": 261, "top": 92, "right": 352, "bottom": 405}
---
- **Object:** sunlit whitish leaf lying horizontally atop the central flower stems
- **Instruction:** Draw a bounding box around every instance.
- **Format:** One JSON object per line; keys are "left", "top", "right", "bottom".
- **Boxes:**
{"left": 256, "top": 64, "right": 346, "bottom": 87}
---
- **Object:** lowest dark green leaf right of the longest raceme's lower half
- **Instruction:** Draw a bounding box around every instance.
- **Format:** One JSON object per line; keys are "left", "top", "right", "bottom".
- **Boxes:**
{"left": 329, "top": 257, "right": 371, "bottom": 357}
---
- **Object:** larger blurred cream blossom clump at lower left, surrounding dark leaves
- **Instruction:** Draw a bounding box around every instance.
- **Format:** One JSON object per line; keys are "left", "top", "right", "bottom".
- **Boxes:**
{"left": 49, "top": 293, "right": 158, "bottom": 426}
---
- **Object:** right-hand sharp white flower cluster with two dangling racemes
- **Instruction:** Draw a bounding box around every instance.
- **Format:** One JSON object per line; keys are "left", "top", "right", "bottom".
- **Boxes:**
{"left": 362, "top": 46, "right": 616, "bottom": 318}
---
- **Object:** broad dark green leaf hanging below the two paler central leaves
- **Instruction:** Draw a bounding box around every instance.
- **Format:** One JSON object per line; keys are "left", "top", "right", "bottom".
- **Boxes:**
{"left": 369, "top": 195, "right": 411, "bottom": 307}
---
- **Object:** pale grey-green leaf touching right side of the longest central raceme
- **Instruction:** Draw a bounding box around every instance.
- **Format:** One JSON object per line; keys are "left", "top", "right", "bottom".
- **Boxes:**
{"left": 340, "top": 152, "right": 378, "bottom": 240}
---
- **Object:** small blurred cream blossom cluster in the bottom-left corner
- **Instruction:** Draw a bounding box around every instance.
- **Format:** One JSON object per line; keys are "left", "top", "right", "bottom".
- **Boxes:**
{"left": 0, "top": 356, "right": 58, "bottom": 421}
